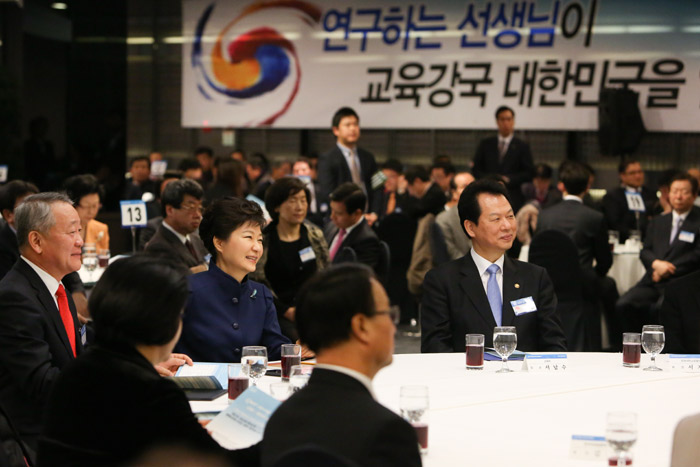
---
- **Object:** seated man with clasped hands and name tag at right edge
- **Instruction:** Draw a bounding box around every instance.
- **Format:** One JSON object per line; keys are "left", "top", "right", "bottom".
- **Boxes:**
{"left": 616, "top": 173, "right": 700, "bottom": 332}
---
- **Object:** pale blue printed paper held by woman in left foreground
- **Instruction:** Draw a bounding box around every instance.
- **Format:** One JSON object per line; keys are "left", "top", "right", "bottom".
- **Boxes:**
{"left": 207, "top": 386, "right": 280, "bottom": 449}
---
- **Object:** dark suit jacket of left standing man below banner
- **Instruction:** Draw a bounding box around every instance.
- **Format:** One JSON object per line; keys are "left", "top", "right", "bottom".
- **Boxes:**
{"left": 318, "top": 145, "right": 381, "bottom": 213}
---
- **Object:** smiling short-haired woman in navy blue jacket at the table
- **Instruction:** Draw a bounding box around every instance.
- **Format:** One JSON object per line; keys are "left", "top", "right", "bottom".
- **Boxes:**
{"left": 177, "top": 198, "right": 290, "bottom": 362}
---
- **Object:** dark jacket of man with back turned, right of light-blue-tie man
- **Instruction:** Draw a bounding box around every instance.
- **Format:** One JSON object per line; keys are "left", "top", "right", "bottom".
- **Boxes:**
{"left": 537, "top": 200, "right": 612, "bottom": 276}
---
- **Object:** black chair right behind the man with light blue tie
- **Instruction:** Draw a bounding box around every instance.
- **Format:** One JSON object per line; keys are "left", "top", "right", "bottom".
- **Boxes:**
{"left": 529, "top": 230, "right": 600, "bottom": 352}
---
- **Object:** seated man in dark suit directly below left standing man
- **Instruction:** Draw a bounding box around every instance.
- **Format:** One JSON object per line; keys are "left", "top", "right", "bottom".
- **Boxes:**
{"left": 324, "top": 182, "right": 381, "bottom": 269}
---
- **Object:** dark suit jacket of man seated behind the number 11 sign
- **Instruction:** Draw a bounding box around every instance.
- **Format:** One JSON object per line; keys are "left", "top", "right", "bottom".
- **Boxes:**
{"left": 603, "top": 186, "right": 658, "bottom": 243}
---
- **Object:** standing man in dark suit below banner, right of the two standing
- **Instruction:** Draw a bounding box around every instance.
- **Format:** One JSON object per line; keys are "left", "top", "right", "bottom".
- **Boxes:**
{"left": 472, "top": 106, "right": 533, "bottom": 212}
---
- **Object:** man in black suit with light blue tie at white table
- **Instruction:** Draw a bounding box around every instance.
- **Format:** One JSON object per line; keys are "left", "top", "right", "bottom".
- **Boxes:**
{"left": 421, "top": 180, "right": 566, "bottom": 352}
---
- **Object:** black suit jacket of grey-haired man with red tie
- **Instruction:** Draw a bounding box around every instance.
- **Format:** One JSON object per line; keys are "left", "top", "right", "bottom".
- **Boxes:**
{"left": 0, "top": 259, "right": 82, "bottom": 449}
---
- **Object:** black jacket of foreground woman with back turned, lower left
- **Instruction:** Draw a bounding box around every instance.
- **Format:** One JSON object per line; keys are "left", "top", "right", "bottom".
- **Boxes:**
{"left": 38, "top": 345, "right": 258, "bottom": 467}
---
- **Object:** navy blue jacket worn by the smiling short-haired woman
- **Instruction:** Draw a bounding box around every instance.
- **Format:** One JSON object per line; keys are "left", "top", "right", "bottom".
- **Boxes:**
{"left": 176, "top": 261, "right": 289, "bottom": 362}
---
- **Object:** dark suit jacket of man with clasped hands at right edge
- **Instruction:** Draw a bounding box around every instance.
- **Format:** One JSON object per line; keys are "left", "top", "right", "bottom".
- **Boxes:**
{"left": 639, "top": 206, "right": 700, "bottom": 286}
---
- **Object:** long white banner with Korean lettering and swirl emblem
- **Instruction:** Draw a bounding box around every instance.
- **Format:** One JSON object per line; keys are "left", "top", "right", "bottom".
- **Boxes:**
{"left": 182, "top": 0, "right": 700, "bottom": 131}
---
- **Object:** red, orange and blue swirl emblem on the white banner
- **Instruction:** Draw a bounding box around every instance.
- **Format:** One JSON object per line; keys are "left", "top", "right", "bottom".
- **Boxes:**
{"left": 191, "top": 0, "right": 321, "bottom": 126}
